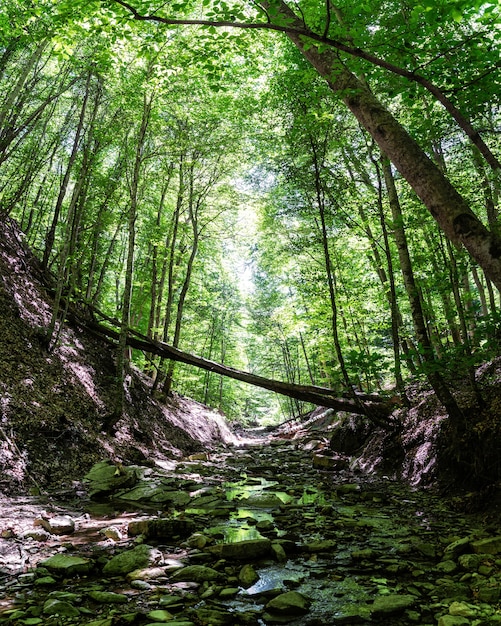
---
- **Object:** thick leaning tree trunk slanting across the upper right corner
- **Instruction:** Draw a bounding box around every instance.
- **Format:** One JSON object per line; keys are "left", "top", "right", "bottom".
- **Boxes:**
{"left": 99, "top": 0, "right": 501, "bottom": 289}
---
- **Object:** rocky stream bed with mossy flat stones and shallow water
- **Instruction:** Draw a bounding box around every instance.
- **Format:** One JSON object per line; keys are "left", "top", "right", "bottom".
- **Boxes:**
{"left": 0, "top": 437, "right": 501, "bottom": 626}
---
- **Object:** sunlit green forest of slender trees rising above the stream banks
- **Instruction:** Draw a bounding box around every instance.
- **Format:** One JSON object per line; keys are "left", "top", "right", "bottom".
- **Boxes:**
{"left": 0, "top": 0, "right": 501, "bottom": 468}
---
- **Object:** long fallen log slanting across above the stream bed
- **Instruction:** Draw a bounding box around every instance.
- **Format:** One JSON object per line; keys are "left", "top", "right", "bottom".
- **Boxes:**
{"left": 73, "top": 312, "right": 395, "bottom": 425}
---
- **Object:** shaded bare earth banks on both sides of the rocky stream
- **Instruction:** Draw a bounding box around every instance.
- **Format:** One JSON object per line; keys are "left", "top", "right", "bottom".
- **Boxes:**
{"left": 0, "top": 213, "right": 501, "bottom": 508}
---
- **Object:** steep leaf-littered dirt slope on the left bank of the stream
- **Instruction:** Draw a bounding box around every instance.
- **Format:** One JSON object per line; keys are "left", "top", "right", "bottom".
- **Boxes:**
{"left": 0, "top": 214, "right": 233, "bottom": 493}
